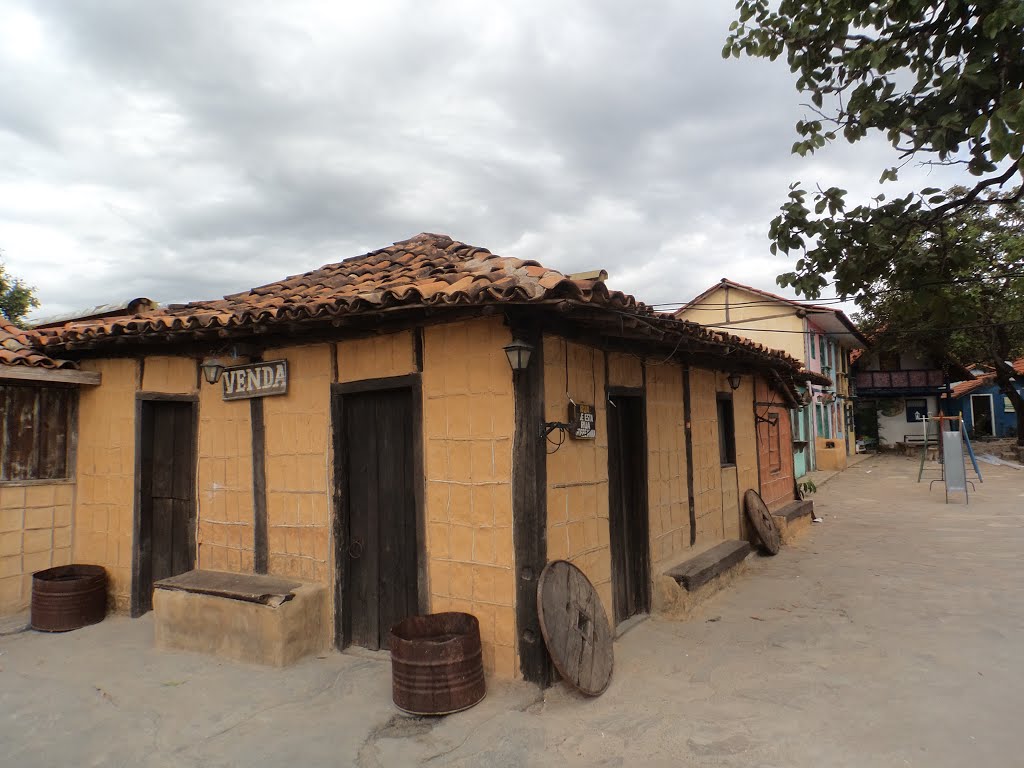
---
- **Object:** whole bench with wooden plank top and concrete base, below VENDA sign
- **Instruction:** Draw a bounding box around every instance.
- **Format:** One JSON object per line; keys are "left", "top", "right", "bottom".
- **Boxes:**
{"left": 153, "top": 570, "right": 330, "bottom": 667}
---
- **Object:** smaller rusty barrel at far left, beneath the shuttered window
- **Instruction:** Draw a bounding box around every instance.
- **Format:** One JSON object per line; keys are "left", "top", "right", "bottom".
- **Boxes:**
{"left": 31, "top": 565, "right": 106, "bottom": 632}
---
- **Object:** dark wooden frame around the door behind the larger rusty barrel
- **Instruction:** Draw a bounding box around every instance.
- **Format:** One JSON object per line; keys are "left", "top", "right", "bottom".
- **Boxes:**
{"left": 331, "top": 374, "right": 430, "bottom": 649}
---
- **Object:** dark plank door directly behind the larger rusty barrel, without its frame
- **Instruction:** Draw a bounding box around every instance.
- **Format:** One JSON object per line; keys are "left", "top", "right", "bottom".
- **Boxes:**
{"left": 336, "top": 389, "right": 419, "bottom": 649}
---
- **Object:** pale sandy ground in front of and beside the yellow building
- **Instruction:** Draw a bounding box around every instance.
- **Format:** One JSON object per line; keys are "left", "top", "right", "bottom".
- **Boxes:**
{"left": 0, "top": 458, "right": 1024, "bottom": 768}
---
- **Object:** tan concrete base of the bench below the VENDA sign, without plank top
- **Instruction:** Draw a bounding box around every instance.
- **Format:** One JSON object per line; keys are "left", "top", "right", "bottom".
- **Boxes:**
{"left": 153, "top": 577, "right": 329, "bottom": 667}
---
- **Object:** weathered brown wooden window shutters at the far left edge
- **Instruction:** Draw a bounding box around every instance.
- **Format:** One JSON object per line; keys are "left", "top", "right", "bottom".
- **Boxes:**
{"left": 0, "top": 384, "right": 78, "bottom": 481}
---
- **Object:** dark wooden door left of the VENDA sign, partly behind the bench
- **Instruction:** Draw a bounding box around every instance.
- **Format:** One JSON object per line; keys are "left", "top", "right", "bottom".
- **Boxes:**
{"left": 134, "top": 400, "right": 196, "bottom": 614}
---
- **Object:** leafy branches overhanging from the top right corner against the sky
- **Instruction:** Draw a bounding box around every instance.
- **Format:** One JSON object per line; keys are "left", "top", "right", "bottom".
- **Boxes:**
{"left": 723, "top": 0, "right": 1024, "bottom": 298}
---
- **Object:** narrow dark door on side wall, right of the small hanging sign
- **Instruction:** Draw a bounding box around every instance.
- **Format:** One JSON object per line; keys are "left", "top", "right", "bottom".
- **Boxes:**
{"left": 606, "top": 395, "right": 650, "bottom": 624}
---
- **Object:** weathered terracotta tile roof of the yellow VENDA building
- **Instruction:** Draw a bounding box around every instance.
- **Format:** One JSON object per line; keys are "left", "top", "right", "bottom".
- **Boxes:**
{"left": 39, "top": 233, "right": 819, "bottom": 391}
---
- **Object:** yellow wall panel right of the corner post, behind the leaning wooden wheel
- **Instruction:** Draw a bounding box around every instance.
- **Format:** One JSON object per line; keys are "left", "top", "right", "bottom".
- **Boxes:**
{"left": 544, "top": 336, "right": 614, "bottom": 620}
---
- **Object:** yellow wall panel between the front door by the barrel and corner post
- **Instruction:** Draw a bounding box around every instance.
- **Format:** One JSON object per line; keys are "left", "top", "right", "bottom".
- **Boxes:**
{"left": 417, "top": 317, "right": 519, "bottom": 678}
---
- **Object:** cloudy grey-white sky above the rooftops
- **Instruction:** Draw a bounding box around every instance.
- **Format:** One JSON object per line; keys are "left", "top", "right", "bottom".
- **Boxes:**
{"left": 0, "top": 0, "right": 970, "bottom": 316}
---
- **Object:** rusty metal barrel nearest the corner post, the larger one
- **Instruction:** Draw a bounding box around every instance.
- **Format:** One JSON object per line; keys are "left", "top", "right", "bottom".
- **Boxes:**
{"left": 390, "top": 612, "right": 486, "bottom": 715}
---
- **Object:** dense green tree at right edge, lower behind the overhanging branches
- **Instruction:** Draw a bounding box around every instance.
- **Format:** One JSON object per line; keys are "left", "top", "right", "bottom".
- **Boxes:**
{"left": 857, "top": 187, "right": 1024, "bottom": 444}
